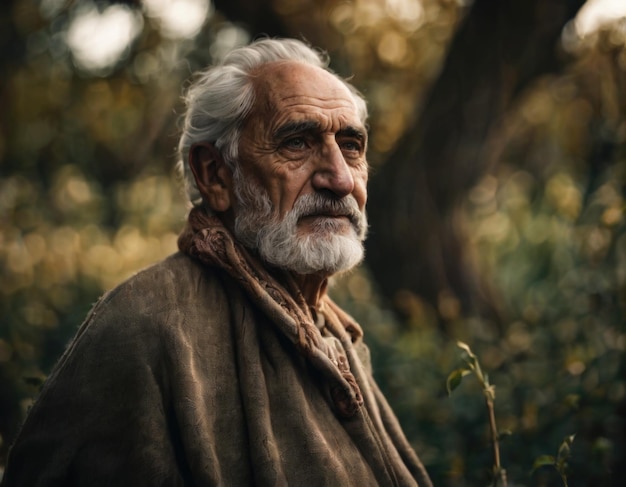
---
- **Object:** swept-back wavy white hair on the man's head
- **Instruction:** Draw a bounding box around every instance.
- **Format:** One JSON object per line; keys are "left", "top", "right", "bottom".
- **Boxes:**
{"left": 178, "top": 39, "right": 367, "bottom": 206}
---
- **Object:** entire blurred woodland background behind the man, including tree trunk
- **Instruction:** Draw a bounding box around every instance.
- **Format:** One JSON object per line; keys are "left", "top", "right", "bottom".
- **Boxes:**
{"left": 0, "top": 0, "right": 626, "bottom": 487}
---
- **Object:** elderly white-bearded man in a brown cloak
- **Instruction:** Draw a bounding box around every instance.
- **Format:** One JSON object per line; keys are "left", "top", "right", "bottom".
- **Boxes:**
{"left": 4, "top": 39, "right": 431, "bottom": 487}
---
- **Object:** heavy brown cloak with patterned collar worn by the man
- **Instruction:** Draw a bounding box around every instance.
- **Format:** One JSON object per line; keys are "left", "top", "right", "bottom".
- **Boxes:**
{"left": 3, "top": 210, "right": 431, "bottom": 487}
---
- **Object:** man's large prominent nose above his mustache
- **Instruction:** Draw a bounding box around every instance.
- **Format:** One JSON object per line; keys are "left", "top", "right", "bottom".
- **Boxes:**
{"left": 312, "top": 139, "right": 354, "bottom": 198}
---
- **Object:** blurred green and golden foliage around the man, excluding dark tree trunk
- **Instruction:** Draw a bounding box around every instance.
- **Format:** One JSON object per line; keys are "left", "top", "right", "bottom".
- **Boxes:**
{"left": 0, "top": 0, "right": 626, "bottom": 487}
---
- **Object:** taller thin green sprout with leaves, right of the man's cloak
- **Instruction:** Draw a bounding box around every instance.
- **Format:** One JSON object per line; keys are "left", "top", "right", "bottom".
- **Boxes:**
{"left": 446, "top": 342, "right": 507, "bottom": 487}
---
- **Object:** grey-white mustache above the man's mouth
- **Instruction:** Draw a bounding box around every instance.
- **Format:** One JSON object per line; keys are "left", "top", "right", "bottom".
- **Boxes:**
{"left": 292, "top": 193, "right": 367, "bottom": 235}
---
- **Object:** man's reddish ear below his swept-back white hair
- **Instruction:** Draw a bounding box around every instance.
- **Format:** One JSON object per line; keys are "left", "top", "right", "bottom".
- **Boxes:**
{"left": 189, "top": 142, "right": 232, "bottom": 212}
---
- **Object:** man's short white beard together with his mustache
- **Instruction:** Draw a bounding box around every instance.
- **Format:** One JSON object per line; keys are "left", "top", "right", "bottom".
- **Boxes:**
{"left": 233, "top": 168, "right": 367, "bottom": 275}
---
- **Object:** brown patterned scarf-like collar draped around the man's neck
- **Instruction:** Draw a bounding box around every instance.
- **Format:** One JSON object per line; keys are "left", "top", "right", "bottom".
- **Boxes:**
{"left": 178, "top": 207, "right": 363, "bottom": 417}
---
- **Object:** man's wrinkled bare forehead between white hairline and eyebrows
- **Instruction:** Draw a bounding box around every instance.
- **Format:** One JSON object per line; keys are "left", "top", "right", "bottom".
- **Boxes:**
{"left": 253, "top": 61, "right": 358, "bottom": 120}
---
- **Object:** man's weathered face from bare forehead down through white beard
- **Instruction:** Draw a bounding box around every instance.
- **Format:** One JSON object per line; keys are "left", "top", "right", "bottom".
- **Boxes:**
{"left": 230, "top": 62, "right": 368, "bottom": 273}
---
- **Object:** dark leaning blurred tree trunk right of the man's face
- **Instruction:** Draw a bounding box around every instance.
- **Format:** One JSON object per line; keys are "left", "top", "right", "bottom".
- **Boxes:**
{"left": 367, "top": 0, "right": 584, "bottom": 330}
